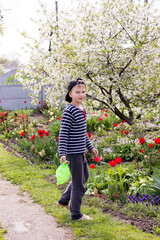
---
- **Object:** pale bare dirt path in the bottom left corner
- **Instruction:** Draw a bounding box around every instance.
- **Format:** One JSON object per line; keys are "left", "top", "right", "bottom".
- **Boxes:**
{"left": 0, "top": 176, "right": 74, "bottom": 240}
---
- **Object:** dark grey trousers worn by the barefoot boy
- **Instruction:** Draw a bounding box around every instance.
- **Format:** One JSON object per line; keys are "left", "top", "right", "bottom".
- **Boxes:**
{"left": 58, "top": 153, "right": 89, "bottom": 220}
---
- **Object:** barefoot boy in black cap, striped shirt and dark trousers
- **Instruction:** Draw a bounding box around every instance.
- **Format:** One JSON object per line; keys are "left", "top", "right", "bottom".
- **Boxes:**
{"left": 57, "top": 78, "right": 98, "bottom": 220}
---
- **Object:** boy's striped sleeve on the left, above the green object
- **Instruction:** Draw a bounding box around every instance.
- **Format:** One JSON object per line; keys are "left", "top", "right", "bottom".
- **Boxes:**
{"left": 59, "top": 110, "right": 73, "bottom": 157}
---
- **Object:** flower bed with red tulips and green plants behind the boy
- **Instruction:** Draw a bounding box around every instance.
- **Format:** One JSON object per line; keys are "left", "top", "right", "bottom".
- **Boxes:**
{"left": 0, "top": 106, "right": 160, "bottom": 235}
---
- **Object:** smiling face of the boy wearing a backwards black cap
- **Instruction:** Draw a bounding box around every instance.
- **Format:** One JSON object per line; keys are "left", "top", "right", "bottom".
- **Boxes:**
{"left": 69, "top": 84, "right": 86, "bottom": 105}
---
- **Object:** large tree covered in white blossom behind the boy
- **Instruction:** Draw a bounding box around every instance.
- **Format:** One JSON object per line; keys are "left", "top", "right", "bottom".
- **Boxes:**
{"left": 17, "top": 0, "right": 160, "bottom": 125}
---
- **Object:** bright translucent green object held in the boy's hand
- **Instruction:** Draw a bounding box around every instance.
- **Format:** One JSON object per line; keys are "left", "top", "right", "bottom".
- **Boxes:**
{"left": 56, "top": 162, "right": 70, "bottom": 185}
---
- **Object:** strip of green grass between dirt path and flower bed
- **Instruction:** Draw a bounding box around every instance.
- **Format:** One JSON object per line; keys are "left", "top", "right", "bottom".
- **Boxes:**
{"left": 0, "top": 145, "right": 160, "bottom": 240}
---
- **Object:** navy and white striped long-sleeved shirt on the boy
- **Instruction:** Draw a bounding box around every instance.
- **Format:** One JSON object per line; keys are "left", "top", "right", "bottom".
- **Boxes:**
{"left": 59, "top": 104, "right": 93, "bottom": 157}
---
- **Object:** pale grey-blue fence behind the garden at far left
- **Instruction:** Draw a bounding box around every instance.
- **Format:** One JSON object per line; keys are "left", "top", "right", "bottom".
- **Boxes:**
{"left": 0, "top": 69, "right": 44, "bottom": 110}
